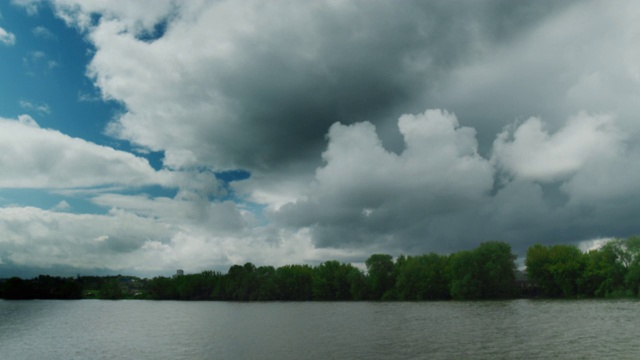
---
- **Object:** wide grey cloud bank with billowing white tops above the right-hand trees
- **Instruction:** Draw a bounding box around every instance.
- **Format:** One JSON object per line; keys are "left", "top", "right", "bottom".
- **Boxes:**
{"left": 273, "top": 111, "right": 640, "bottom": 255}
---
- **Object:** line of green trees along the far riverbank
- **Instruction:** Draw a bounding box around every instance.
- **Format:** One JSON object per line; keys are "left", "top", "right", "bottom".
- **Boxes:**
{"left": 0, "top": 238, "right": 640, "bottom": 301}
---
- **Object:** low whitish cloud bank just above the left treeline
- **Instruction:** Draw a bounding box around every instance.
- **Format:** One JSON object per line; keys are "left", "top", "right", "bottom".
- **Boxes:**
{"left": 0, "top": 200, "right": 366, "bottom": 276}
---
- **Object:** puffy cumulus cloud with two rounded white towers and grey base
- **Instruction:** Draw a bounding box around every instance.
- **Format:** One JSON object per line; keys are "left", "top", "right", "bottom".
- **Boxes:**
{"left": 276, "top": 110, "right": 493, "bottom": 250}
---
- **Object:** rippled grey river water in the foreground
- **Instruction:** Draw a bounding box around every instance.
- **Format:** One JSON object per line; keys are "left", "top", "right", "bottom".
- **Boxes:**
{"left": 0, "top": 300, "right": 640, "bottom": 360}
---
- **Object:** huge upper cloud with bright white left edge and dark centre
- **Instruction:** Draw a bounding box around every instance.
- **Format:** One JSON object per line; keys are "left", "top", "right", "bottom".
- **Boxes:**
{"left": 86, "top": 1, "right": 568, "bottom": 171}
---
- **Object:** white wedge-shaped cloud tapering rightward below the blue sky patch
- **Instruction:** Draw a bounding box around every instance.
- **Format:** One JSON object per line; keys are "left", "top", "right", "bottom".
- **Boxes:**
{"left": 0, "top": 115, "right": 167, "bottom": 189}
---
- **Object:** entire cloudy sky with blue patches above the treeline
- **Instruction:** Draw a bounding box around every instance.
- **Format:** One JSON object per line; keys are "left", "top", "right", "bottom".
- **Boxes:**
{"left": 0, "top": 0, "right": 640, "bottom": 277}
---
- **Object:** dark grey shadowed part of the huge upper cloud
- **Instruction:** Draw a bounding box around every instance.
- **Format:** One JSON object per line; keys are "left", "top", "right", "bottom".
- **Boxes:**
{"left": 211, "top": 1, "right": 580, "bottom": 168}
